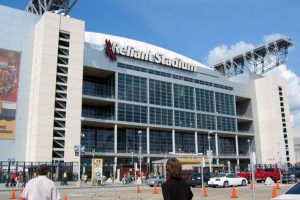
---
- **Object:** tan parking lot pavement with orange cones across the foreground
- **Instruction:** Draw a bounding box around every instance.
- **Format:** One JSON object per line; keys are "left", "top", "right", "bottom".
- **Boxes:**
{"left": 0, "top": 183, "right": 293, "bottom": 200}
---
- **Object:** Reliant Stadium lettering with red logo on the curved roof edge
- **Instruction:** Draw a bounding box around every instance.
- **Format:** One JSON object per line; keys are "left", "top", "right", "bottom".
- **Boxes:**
{"left": 105, "top": 39, "right": 196, "bottom": 72}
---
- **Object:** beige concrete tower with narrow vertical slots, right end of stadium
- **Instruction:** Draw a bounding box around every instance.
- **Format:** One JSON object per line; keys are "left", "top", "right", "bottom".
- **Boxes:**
{"left": 255, "top": 76, "right": 295, "bottom": 164}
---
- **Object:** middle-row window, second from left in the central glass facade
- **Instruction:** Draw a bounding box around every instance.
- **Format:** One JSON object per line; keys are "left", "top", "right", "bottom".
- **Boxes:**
{"left": 150, "top": 107, "right": 173, "bottom": 126}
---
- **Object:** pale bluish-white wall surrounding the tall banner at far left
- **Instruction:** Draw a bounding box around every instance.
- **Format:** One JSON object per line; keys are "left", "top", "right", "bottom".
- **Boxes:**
{"left": 0, "top": 5, "right": 40, "bottom": 161}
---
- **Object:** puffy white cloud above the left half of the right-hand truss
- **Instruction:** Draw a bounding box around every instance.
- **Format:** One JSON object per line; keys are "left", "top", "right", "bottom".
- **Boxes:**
{"left": 207, "top": 41, "right": 255, "bottom": 65}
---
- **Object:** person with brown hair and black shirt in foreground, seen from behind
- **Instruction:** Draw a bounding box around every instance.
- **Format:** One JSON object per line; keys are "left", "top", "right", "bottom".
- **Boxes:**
{"left": 162, "top": 158, "right": 193, "bottom": 200}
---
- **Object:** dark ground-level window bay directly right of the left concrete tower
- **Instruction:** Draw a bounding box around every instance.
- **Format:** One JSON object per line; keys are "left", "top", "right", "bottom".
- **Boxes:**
{"left": 81, "top": 127, "right": 114, "bottom": 152}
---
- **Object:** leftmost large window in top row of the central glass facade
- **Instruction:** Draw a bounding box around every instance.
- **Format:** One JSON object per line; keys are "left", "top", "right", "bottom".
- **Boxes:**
{"left": 118, "top": 73, "right": 147, "bottom": 103}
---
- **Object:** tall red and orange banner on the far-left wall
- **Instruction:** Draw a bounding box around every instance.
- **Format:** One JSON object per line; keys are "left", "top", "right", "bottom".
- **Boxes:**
{"left": 0, "top": 48, "right": 21, "bottom": 140}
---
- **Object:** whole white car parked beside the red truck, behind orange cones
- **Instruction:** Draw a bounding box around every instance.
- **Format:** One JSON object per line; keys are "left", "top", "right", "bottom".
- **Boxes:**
{"left": 208, "top": 173, "right": 248, "bottom": 187}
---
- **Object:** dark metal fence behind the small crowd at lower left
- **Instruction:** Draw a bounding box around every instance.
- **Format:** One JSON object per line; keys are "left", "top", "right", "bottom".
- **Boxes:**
{"left": 0, "top": 161, "right": 78, "bottom": 183}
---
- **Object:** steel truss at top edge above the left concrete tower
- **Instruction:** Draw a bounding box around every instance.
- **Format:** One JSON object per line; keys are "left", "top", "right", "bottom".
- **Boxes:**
{"left": 25, "top": 0, "right": 77, "bottom": 15}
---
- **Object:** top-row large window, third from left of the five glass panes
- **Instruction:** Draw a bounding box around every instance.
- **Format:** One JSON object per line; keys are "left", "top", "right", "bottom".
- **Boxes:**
{"left": 174, "top": 84, "right": 194, "bottom": 110}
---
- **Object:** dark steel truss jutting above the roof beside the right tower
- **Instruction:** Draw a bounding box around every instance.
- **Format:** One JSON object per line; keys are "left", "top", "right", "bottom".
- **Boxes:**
{"left": 211, "top": 38, "right": 293, "bottom": 77}
